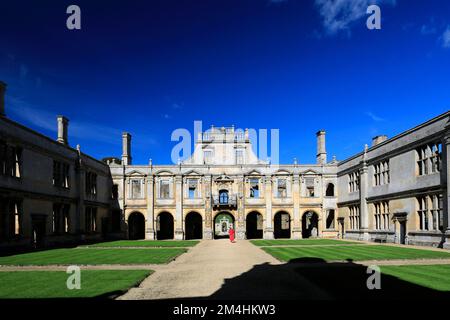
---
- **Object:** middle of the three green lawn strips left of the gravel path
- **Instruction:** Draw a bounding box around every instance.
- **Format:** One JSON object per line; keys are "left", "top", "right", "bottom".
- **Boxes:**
{"left": 0, "top": 248, "right": 187, "bottom": 265}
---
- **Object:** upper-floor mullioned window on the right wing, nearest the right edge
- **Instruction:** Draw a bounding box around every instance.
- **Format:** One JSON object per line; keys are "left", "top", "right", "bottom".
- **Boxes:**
{"left": 416, "top": 142, "right": 442, "bottom": 176}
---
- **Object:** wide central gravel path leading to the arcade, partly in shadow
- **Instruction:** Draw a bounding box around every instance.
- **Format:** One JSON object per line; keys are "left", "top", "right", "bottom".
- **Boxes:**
{"left": 119, "top": 239, "right": 329, "bottom": 300}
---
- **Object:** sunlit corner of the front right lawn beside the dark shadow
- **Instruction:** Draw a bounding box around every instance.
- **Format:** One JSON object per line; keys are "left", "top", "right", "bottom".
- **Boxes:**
{"left": 381, "top": 264, "right": 450, "bottom": 291}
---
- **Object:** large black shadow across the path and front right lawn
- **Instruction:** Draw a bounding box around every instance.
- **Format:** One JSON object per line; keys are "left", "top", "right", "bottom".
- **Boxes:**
{"left": 203, "top": 258, "right": 450, "bottom": 300}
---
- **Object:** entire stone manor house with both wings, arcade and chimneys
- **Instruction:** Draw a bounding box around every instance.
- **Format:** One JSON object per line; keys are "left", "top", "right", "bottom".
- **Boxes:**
{"left": 0, "top": 82, "right": 450, "bottom": 248}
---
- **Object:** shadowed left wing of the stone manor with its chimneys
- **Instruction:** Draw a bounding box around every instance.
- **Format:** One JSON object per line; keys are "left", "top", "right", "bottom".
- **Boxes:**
{"left": 0, "top": 82, "right": 112, "bottom": 249}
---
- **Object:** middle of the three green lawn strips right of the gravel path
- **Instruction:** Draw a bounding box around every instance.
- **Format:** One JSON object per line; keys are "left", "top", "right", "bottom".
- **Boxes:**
{"left": 262, "top": 245, "right": 450, "bottom": 261}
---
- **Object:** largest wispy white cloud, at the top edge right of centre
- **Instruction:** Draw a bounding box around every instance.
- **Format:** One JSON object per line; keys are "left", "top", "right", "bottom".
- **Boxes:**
{"left": 315, "top": 0, "right": 396, "bottom": 35}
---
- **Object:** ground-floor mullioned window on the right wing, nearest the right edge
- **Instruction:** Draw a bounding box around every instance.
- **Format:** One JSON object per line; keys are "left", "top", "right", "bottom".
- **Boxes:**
{"left": 417, "top": 194, "right": 443, "bottom": 231}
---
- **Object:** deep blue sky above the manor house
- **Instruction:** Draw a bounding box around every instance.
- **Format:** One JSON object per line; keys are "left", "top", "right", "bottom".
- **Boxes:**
{"left": 0, "top": 0, "right": 450, "bottom": 164}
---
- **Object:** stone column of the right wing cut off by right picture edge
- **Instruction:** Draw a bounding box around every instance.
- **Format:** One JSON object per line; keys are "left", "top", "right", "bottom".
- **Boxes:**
{"left": 441, "top": 131, "right": 450, "bottom": 249}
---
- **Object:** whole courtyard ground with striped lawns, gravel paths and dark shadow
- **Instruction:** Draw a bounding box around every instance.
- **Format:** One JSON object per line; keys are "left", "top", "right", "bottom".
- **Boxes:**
{"left": 0, "top": 239, "right": 450, "bottom": 300}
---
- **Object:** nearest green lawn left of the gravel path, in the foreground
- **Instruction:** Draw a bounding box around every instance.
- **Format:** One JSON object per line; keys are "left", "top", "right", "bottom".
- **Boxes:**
{"left": 0, "top": 270, "right": 152, "bottom": 299}
